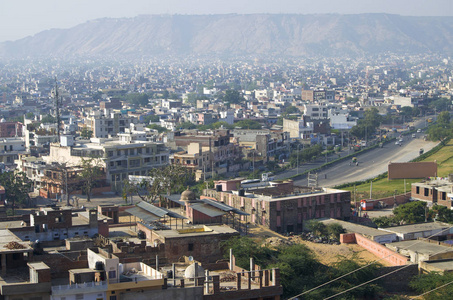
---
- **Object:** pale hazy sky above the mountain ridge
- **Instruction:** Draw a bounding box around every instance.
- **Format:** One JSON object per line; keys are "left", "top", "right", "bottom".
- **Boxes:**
{"left": 0, "top": 0, "right": 453, "bottom": 42}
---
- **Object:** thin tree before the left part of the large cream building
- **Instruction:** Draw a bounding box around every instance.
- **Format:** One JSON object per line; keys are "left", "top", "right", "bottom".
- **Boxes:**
{"left": 78, "top": 157, "right": 104, "bottom": 202}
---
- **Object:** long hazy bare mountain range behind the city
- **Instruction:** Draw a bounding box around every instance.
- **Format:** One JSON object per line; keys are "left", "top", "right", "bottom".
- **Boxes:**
{"left": 0, "top": 14, "right": 453, "bottom": 58}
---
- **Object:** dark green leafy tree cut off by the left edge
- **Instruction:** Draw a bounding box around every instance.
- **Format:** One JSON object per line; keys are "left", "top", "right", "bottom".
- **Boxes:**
{"left": 0, "top": 171, "right": 33, "bottom": 214}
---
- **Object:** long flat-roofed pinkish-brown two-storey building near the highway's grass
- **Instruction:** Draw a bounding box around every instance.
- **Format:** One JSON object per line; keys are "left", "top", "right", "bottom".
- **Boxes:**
{"left": 205, "top": 180, "right": 351, "bottom": 233}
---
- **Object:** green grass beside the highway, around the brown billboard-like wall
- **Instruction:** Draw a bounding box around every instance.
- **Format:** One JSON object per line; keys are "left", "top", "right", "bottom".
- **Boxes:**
{"left": 342, "top": 140, "right": 453, "bottom": 201}
